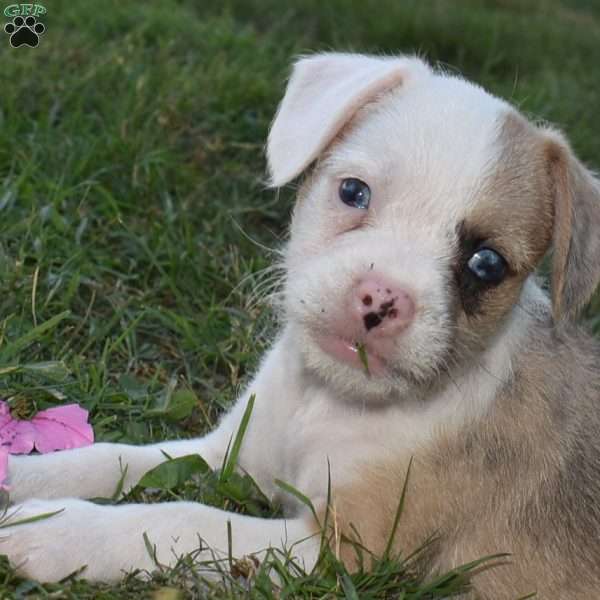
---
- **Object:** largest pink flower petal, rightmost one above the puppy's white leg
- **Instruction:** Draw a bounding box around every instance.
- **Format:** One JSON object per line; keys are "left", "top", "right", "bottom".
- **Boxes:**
{"left": 31, "top": 404, "right": 94, "bottom": 453}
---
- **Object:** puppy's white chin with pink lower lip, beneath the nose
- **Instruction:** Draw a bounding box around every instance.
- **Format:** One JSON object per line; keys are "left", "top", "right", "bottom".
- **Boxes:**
{"left": 294, "top": 325, "right": 416, "bottom": 403}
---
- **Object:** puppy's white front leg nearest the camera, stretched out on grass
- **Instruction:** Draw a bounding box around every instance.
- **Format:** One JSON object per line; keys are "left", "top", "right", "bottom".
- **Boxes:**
{"left": 0, "top": 498, "right": 320, "bottom": 581}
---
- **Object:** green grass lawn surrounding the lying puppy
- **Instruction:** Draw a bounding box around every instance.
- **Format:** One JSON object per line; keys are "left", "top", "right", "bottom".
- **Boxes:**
{"left": 0, "top": 0, "right": 600, "bottom": 600}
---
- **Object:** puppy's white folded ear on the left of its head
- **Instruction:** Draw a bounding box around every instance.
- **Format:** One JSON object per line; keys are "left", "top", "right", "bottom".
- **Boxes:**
{"left": 267, "top": 53, "right": 429, "bottom": 187}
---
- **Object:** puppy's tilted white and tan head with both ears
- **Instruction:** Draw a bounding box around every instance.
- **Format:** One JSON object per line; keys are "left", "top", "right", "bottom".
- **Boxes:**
{"left": 267, "top": 54, "right": 600, "bottom": 404}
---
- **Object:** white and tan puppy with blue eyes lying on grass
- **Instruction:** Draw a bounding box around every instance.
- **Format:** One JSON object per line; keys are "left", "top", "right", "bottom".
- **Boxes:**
{"left": 0, "top": 54, "right": 600, "bottom": 600}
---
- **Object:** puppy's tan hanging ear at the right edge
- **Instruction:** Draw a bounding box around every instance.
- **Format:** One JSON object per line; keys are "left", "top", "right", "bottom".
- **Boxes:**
{"left": 545, "top": 130, "right": 600, "bottom": 322}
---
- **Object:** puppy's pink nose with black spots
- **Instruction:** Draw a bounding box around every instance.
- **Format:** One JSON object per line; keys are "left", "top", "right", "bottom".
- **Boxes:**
{"left": 352, "top": 275, "right": 415, "bottom": 336}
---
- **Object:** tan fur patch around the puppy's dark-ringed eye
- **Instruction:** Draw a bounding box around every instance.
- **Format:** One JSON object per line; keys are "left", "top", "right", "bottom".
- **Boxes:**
{"left": 456, "top": 111, "right": 554, "bottom": 349}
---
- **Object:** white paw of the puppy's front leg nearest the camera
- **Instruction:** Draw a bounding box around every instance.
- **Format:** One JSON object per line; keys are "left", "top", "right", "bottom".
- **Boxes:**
{"left": 0, "top": 499, "right": 152, "bottom": 581}
